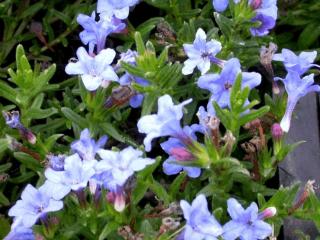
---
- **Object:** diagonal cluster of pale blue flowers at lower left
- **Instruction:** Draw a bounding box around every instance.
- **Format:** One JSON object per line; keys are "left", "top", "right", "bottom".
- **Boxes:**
{"left": 6, "top": 129, "right": 155, "bottom": 239}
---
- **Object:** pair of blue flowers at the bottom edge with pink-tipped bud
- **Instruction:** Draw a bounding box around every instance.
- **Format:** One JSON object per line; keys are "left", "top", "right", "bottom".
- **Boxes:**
{"left": 180, "top": 194, "right": 276, "bottom": 240}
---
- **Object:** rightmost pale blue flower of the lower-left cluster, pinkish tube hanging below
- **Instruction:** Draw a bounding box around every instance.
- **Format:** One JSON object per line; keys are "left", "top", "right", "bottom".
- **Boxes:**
{"left": 93, "top": 147, "right": 155, "bottom": 212}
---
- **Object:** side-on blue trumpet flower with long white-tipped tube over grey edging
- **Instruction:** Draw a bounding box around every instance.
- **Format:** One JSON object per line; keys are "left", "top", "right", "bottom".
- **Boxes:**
{"left": 275, "top": 71, "right": 320, "bottom": 132}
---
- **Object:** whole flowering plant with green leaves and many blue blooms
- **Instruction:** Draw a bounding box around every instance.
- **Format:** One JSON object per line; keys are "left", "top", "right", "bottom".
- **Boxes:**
{"left": 0, "top": 0, "right": 320, "bottom": 240}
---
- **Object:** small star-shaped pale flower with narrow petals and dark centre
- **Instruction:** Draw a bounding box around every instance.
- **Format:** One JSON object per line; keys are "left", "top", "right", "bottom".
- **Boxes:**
{"left": 182, "top": 28, "right": 222, "bottom": 75}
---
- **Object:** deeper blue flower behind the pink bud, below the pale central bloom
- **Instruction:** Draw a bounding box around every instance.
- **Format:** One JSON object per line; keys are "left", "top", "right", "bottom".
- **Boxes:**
{"left": 160, "top": 125, "right": 201, "bottom": 178}
